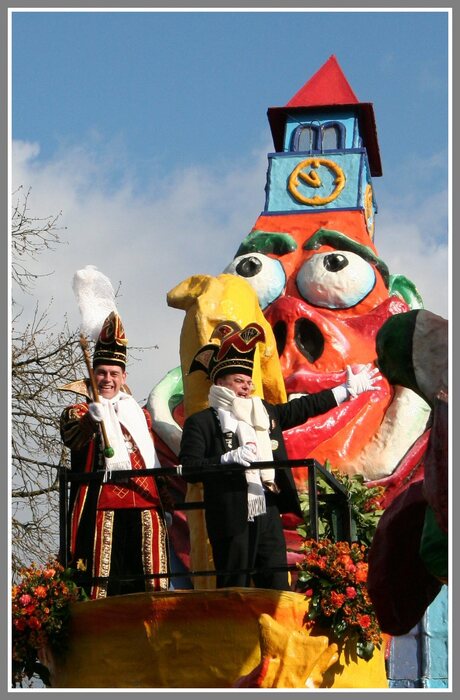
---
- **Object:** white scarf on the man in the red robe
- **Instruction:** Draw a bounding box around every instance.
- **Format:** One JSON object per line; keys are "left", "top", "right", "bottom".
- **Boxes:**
{"left": 99, "top": 392, "right": 161, "bottom": 474}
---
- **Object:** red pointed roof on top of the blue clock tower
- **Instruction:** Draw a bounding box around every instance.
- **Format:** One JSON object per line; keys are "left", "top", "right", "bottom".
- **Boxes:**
{"left": 267, "top": 55, "right": 382, "bottom": 176}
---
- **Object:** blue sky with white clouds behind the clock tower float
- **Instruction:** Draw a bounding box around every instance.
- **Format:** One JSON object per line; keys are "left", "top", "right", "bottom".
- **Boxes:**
{"left": 11, "top": 10, "right": 449, "bottom": 399}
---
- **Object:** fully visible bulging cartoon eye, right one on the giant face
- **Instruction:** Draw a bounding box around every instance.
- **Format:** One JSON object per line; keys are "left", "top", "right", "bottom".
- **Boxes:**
{"left": 297, "top": 250, "right": 375, "bottom": 309}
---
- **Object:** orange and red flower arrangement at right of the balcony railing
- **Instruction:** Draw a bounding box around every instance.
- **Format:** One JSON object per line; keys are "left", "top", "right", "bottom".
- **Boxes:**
{"left": 297, "top": 539, "right": 383, "bottom": 660}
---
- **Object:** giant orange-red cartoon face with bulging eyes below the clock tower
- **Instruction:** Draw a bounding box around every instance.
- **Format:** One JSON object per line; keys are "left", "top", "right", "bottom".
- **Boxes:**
{"left": 148, "top": 212, "right": 430, "bottom": 588}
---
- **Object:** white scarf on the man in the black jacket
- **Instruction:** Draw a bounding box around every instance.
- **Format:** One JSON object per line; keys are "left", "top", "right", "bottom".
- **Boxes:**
{"left": 209, "top": 384, "right": 275, "bottom": 520}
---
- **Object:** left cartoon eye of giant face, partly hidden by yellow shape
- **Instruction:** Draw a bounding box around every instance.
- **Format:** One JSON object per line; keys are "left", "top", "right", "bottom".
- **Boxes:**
{"left": 224, "top": 253, "right": 286, "bottom": 309}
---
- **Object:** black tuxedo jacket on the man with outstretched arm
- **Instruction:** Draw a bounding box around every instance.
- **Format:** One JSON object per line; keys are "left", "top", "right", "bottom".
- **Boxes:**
{"left": 179, "top": 389, "right": 337, "bottom": 539}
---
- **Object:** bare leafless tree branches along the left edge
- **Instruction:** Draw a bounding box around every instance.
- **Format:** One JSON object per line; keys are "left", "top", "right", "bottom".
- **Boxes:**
{"left": 11, "top": 188, "right": 84, "bottom": 575}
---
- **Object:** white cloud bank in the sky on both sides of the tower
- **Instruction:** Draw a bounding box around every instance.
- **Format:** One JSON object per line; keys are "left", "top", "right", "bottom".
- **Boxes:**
{"left": 12, "top": 137, "right": 448, "bottom": 400}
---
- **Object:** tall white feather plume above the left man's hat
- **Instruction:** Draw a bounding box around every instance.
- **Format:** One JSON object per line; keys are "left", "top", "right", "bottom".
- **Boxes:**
{"left": 72, "top": 265, "right": 117, "bottom": 341}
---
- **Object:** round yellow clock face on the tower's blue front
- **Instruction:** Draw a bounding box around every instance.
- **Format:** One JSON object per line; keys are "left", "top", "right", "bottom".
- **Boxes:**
{"left": 288, "top": 158, "right": 346, "bottom": 206}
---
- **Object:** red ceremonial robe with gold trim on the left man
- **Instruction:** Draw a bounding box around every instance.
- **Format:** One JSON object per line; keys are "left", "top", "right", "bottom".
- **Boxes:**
{"left": 61, "top": 386, "right": 168, "bottom": 598}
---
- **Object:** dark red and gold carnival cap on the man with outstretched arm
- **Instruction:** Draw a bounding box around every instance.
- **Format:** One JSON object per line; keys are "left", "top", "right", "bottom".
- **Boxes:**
{"left": 189, "top": 321, "right": 265, "bottom": 382}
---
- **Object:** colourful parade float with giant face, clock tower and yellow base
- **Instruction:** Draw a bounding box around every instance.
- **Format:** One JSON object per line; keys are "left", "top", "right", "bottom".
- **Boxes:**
{"left": 10, "top": 56, "right": 447, "bottom": 688}
